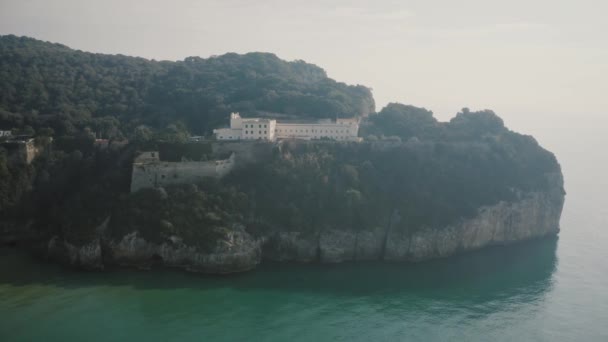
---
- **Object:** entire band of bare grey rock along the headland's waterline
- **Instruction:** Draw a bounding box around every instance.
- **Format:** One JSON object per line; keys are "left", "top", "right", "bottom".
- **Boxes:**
{"left": 14, "top": 171, "right": 564, "bottom": 274}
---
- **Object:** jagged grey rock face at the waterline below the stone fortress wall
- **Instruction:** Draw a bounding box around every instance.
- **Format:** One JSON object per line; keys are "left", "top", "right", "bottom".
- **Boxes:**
{"left": 107, "top": 229, "right": 261, "bottom": 274}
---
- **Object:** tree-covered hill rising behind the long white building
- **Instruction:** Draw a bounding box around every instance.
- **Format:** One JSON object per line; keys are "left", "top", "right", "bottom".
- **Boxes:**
{"left": 0, "top": 35, "right": 375, "bottom": 138}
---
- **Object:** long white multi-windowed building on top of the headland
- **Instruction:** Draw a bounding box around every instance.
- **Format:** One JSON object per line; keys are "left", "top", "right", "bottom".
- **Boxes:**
{"left": 213, "top": 113, "right": 360, "bottom": 141}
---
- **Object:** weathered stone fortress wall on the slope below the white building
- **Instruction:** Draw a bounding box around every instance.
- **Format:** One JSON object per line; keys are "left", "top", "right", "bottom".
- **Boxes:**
{"left": 131, "top": 152, "right": 235, "bottom": 192}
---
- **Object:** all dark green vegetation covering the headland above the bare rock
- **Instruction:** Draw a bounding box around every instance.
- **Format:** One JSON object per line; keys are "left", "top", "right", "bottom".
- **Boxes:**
{"left": 0, "top": 36, "right": 559, "bottom": 248}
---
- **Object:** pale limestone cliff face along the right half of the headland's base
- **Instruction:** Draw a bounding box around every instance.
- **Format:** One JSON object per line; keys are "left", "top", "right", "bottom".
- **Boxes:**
{"left": 264, "top": 174, "right": 564, "bottom": 263}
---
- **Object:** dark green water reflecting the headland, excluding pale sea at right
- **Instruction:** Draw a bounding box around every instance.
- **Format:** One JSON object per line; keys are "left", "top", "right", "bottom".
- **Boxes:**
{"left": 0, "top": 239, "right": 557, "bottom": 341}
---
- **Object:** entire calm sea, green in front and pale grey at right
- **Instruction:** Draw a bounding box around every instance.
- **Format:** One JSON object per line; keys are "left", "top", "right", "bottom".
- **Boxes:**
{"left": 0, "top": 116, "right": 608, "bottom": 341}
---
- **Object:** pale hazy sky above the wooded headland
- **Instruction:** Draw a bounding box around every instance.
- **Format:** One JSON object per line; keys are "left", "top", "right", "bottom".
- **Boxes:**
{"left": 0, "top": 0, "right": 608, "bottom": 122}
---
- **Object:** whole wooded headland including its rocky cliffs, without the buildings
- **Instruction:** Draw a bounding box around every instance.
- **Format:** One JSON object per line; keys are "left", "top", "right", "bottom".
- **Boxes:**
{"left": 0, "top": 36, "right": 565, "bottom": 273}
